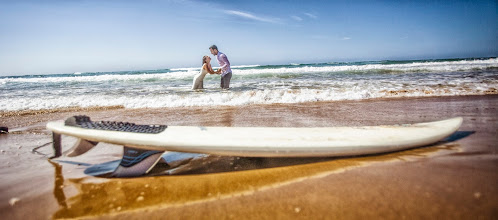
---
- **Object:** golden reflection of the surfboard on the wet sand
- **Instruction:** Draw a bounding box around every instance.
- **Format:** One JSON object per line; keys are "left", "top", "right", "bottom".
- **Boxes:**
{"left": 49, "top": 132, "right": 466, "bottom": 218}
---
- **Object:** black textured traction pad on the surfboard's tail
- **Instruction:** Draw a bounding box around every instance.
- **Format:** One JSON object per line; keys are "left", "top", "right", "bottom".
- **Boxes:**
{"left": 64, "top": 115, "right": 168, "bottom": 134}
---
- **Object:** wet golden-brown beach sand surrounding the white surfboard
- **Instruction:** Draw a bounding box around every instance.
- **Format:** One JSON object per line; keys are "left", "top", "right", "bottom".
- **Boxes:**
{"left": 0, "top": 95, "right": 498, "bottom": 219}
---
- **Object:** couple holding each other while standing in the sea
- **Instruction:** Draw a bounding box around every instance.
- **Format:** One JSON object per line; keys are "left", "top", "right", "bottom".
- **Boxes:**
{"left": 192, "top": 45, "right": 232, "bottom": 89}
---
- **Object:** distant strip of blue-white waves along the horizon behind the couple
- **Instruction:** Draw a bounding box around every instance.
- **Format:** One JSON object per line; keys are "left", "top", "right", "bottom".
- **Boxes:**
{"left": 0, "top": 58, "right": 498, "bottom": 85}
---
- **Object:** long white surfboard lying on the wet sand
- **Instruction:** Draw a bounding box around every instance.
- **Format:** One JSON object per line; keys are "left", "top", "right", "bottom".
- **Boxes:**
{"left": 47, "top": 116, "right": 463, "bottom": 176}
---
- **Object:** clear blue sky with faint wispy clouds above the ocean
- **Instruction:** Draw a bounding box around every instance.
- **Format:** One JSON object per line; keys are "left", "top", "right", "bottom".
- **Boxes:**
{"left": 0, "top": 0, "right": 498, "bottom": 76}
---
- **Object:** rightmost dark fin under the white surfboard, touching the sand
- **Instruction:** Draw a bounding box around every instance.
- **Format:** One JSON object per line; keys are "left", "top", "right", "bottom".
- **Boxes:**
{"left": 111, "top": 146, "right": 164, "bottom": 177}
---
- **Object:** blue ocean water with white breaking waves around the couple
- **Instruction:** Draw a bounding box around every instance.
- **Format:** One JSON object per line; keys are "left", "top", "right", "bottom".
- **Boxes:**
{"left": 0, "top": 58, "right": 498, "bottom": 112}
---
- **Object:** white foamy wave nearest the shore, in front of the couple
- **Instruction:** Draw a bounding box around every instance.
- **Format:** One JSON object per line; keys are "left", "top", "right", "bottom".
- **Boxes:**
{"left": 0, "top": 82, "right": 498, "bottom": 111}
